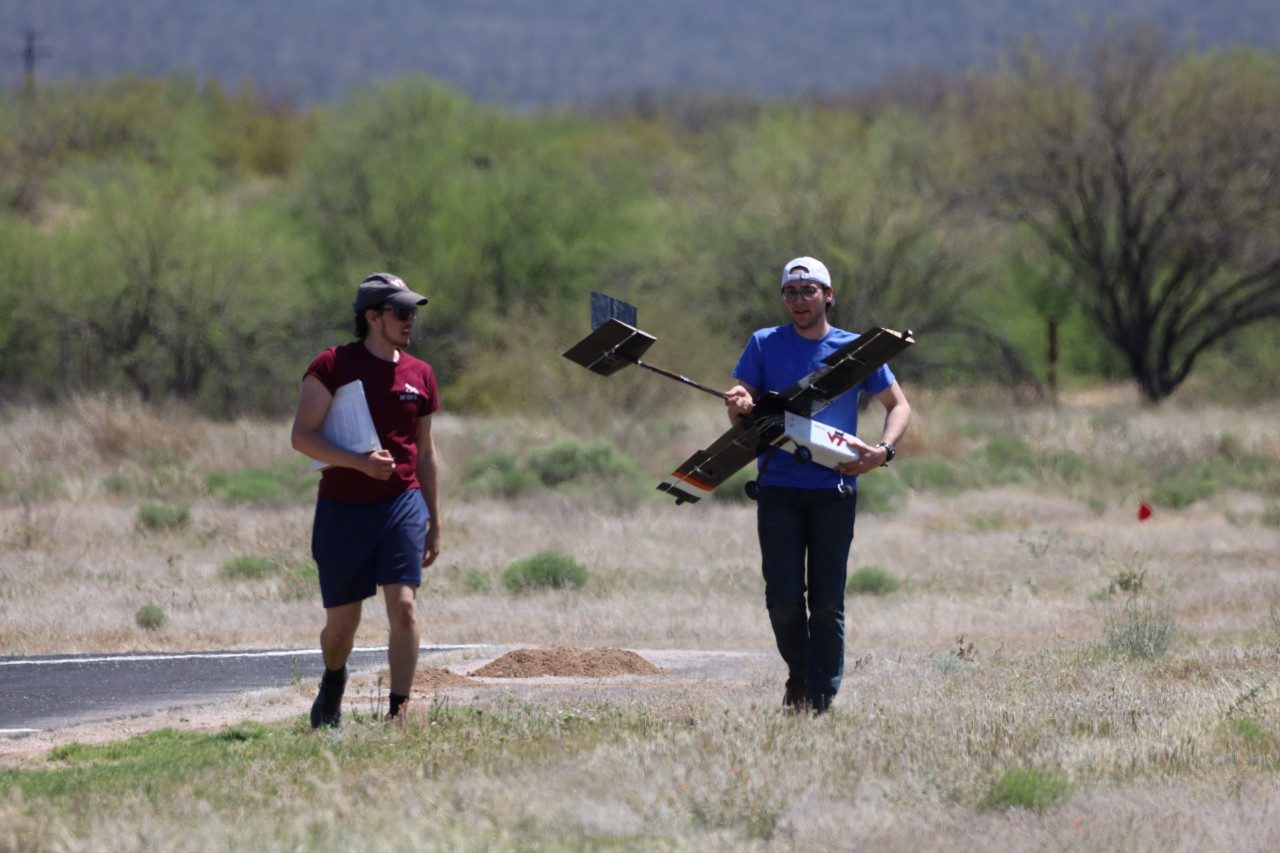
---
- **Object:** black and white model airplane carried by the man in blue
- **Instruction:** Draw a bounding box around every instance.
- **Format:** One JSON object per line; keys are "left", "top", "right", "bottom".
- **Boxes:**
{"left": 564, "top": 293, "right": 915, "bottom": 503}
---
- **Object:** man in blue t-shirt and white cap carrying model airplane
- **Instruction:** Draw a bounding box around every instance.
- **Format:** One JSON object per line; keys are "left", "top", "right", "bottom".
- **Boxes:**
{"left": 724, "top": 257, "right": 911, "bottom": 713}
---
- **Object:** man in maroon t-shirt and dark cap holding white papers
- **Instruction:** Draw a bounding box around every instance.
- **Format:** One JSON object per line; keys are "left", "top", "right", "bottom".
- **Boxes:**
{"left": 292, "top": 273, "right": 440, "bottom": 727}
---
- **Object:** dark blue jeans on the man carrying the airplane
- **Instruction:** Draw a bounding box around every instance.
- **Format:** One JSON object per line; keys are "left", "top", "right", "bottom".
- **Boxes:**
{"left": 755, "top": 485, "right": 858, "bottom": 708}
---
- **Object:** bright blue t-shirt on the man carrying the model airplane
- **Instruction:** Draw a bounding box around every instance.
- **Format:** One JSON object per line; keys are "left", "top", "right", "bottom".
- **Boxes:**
{"left": 733, "top": 323, "right": 893, "bottom": 489}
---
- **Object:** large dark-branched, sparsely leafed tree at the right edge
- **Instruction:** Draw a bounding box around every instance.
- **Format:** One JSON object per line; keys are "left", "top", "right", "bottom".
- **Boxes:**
{"left": 961, "top": 29, "right": 1280, "bottom": 402}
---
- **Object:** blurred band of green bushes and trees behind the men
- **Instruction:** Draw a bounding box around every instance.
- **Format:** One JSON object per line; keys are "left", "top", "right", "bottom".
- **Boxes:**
{"left": 0, "top": 29, "right": 1280, "bottom": 418}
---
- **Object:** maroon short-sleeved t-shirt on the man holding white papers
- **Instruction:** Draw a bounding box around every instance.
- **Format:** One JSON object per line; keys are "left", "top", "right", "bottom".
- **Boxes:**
{"left": 305, "top": 341, "right": 440, "bottom": 503}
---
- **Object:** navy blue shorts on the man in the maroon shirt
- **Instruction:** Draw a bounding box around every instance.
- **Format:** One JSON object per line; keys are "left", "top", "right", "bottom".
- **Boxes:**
{"left": 311, "top": 489, "right": 431, "bottom": 608}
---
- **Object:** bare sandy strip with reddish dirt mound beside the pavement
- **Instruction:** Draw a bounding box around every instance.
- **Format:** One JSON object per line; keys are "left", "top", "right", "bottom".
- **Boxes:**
{"left": 0, "top": 646, "right": 782, "bottom": 767}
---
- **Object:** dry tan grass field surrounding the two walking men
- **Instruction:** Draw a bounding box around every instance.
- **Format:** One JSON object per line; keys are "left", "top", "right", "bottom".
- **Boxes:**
{"left": 0, "top": 397, "right": 1280, "bottom": 849}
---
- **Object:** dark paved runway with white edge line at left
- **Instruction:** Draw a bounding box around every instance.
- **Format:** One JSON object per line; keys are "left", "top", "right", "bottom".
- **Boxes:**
{"left": 0, "top": 646, "right": 470, "bottom": 736}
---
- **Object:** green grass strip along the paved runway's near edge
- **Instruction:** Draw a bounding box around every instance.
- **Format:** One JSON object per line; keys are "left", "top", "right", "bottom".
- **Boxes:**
{"left": 0, "top": 706, "right": 619, "bottom": 809}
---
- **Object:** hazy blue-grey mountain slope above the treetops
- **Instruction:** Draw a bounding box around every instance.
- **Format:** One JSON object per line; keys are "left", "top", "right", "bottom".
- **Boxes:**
{"left": 0, "top": 0, "right": 1280, "bottom": 108}
